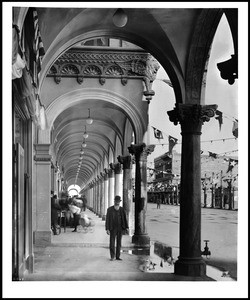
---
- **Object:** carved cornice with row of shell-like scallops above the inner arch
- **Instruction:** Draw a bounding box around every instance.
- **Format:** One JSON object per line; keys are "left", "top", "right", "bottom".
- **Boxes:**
{"left": 47, "top": 49, "right": 160, "bottom": 86}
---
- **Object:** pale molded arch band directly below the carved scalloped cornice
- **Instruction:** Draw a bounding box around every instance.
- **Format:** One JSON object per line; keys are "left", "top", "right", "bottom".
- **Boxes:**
{"left": 43, "top": 88, "right": 147, "bottom": 143}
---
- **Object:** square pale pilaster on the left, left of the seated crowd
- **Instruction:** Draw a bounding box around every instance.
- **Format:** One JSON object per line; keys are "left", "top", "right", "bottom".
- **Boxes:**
{"left": 34, "top": 144, "right": 51, "bottom": 246}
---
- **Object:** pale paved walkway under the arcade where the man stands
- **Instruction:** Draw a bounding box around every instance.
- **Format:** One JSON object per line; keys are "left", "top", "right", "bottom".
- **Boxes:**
{"left": 24, "top": 210, "right": 232, "bottom": 281}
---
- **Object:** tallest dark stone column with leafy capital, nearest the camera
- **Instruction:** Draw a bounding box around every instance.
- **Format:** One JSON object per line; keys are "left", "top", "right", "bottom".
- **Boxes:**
{"left": 168, "top": 104, "right": 217, "bottom": 276}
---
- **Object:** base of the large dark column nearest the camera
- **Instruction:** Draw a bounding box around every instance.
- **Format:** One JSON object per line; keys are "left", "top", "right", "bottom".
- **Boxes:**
{"left": 174, "top": 258, "right": 206, "bottom": 277}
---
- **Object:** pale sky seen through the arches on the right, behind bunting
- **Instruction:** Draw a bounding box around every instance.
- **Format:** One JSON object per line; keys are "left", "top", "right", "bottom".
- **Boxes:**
{"left": 148, "top": 16, "right": 238, "bottom": 162}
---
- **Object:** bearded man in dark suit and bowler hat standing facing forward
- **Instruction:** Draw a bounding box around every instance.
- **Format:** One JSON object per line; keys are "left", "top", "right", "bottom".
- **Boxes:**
{"left": 105, "top": 196, "right": 128, "bottom": 261}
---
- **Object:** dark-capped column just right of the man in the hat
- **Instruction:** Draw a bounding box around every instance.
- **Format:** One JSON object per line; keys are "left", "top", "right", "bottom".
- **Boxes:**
{"left": 128, "top": 143, "right": 150, "bottom": 248}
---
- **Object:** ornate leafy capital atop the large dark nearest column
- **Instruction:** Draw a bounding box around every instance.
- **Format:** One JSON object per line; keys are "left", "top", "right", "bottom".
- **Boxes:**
{"left": 167, "top": 103, "right": 218, "bottom": 133}
